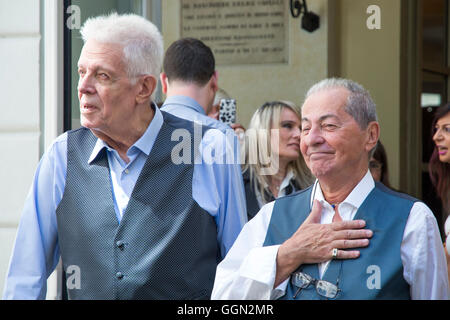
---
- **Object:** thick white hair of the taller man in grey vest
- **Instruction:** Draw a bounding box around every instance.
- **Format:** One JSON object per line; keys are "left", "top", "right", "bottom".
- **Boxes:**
{"left": 80, "top": 13, "right": 164, "bottom": 80}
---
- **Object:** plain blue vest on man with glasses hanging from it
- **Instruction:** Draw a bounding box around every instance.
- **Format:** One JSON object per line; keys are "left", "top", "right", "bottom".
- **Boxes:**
{"left": 264, "top": 183, "right": 417, "bottom": 300}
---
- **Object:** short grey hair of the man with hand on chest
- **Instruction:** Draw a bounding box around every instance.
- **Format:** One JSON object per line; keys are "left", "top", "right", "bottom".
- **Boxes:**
{"left": 306, "top": 78, "right": 378, "bottom": 129}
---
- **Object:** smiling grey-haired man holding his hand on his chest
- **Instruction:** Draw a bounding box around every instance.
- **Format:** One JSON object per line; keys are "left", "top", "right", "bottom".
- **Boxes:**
{"left": 212, "top": 79, "right": 448, "bottom": 299}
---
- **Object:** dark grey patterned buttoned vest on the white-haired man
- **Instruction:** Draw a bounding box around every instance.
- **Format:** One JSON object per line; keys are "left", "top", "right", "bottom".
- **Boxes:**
{"left": 56, "top": 112, "right": 219, "bottom": 299}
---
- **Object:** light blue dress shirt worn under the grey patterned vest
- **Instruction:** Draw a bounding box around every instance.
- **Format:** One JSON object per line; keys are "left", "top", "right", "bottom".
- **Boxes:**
{"left": 3, "top": 107, "right": 246, "bottom": 299}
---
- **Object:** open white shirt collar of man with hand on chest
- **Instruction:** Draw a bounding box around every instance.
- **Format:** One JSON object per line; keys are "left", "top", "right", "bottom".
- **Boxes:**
{"left": 311, "top": 170, "right": 375, "bottom": 209}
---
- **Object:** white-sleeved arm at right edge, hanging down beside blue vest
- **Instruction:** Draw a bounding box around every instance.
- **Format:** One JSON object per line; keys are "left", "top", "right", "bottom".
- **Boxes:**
{"left": 401, "top": 202, "right": 449, "bottom": 300}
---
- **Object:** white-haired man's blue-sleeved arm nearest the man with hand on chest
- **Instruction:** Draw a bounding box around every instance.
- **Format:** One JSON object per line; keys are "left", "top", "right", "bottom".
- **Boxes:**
{"left": 193, "top": 129, "right": 247, "bottom": 258}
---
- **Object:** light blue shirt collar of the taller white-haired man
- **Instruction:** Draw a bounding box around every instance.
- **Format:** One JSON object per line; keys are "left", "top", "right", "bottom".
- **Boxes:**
{"left": 88, "top": 104, "right": 163, "bottom": 164}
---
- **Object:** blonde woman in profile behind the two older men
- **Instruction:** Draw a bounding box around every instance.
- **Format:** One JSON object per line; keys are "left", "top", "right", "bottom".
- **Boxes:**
{"left": 243, "top": 101, "right": 314, "bottom": 220}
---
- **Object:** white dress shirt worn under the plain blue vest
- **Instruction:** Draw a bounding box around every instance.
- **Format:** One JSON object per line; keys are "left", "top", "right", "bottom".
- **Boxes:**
{"left": 211, "top": 171, "right": 449, "bottom": 300}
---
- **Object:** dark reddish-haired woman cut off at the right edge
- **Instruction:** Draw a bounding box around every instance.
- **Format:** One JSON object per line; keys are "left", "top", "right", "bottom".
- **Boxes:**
{"left": 429, "top": 103, "right": 450, "bottom": 279}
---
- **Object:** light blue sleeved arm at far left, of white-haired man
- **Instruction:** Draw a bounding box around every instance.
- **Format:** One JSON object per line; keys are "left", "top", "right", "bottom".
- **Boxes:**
{"left": 3, "top": 135, "right": 67, "bottom": 299}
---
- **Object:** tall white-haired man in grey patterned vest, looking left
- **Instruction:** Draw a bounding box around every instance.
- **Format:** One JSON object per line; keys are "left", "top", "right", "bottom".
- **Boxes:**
{"left": 4, "top": 14, "right": 246, "bottom": 299}
